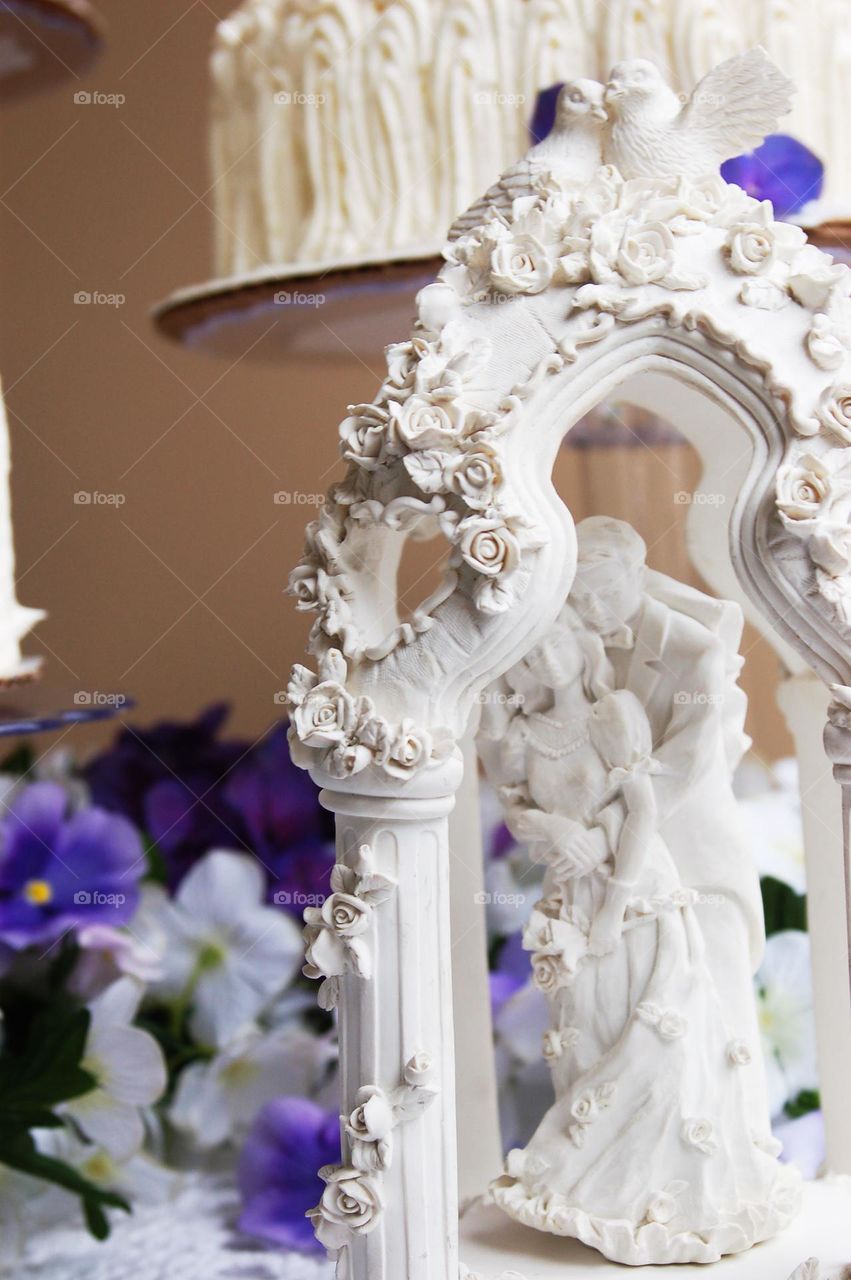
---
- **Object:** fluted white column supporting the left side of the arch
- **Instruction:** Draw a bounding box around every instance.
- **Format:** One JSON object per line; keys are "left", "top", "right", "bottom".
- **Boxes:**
{"left": 312, "top": 756, "right": 462, "bottom": 1280}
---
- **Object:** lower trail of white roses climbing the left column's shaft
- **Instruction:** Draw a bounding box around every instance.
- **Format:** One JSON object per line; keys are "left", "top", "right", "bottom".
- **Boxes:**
{"left": 308, "top": 1052, "right": 436, "bottom": 1254}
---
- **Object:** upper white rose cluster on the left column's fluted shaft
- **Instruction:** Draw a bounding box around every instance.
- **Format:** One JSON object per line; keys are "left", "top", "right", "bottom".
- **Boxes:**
{"left": 303, "top": 845, "right": 395, "bottom": 1009}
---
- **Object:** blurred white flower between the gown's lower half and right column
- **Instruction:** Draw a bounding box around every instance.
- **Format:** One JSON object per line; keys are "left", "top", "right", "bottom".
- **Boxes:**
{"left": 755, "top": 929, "right": 818, "bottom": 1116}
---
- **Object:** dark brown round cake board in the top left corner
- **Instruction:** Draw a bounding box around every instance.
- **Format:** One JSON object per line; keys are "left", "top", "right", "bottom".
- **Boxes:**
{"left": 0, "top": 0, "right": 102, "bottom": 102}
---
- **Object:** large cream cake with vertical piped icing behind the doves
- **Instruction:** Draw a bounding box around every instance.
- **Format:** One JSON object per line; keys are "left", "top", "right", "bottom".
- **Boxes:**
{"left": 212, "top": 0, "right": 851, "bottom": 275}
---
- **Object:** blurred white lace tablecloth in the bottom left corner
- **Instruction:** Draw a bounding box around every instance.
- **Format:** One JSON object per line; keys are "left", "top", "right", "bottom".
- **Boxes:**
{"left": 12, "top": 1176, "right": 334, "bottom": 1280}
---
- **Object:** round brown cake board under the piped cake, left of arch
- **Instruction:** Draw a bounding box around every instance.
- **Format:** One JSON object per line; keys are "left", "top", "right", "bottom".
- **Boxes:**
{"left": 154, "top": 250, "right": 441, "bottom": 364}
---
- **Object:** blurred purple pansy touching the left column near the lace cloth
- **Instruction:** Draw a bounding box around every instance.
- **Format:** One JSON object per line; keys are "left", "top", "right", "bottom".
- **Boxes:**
{"left": 238, "top": 1098, "right": 340, "bottom": 1253}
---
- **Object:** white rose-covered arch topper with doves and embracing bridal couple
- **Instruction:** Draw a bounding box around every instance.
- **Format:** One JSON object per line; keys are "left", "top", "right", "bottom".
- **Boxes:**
{"left": 288, "top": 52, "right": 851, "bottom": 1280}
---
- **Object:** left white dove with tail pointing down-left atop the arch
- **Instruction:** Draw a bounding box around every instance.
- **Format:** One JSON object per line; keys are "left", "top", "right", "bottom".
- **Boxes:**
{"left": 448, "top": 79, "right": 607, "bottom": 241}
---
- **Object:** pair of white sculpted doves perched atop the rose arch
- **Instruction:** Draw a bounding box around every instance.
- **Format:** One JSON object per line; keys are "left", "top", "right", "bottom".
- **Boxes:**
{"left": 449, "top": 47, "right": 795, "bottom": 241}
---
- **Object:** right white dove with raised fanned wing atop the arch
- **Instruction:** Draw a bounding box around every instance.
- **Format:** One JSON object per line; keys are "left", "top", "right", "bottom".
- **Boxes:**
{"left": 605, "top": 47, "right": 795, "bottom": 178}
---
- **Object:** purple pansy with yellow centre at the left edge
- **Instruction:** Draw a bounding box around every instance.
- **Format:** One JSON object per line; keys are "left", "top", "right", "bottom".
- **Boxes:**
{"left": 0, "top": 782, "right": 145, "bottom": 948}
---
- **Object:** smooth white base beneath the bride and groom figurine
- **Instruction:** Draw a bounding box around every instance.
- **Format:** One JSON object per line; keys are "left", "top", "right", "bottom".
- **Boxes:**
{"left": 461, "top": 1178, "right": 851, "bottom": 1280}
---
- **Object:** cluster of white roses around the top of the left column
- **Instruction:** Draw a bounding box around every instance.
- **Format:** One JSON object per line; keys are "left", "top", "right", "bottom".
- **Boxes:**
{"left": 287, "top": 649, "right": 452, "bottom": 782}
